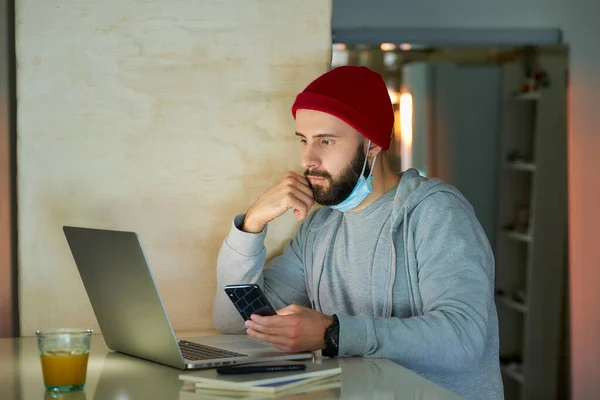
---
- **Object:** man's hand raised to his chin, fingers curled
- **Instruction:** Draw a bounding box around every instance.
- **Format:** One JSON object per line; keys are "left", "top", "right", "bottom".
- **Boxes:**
{"left": 242, "top": 172, "right": 315, "bottom": 233}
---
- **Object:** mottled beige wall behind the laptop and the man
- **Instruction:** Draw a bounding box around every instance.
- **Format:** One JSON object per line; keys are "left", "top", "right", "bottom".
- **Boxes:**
{"left": 17, "top": 0, "right": 331, "bottom": 336}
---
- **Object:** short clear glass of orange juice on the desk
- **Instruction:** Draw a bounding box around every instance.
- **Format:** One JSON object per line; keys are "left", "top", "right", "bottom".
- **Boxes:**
{"left": 35, "top": 329, "right": 93, "bottom": 392}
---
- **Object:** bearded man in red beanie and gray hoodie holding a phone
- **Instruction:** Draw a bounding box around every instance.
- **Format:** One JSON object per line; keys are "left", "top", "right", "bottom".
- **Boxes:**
{"left": 214, "top": 67, "right": 503, "bottom": 399}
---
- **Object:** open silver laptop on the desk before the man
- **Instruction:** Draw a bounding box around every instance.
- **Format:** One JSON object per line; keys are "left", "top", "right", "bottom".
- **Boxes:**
{"left": 63, "top": 226, "right": 312, "bottom": 369}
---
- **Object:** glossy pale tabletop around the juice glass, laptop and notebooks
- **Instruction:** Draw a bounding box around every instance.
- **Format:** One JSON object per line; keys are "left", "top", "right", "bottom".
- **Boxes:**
{"left": 0, "top": 335, "right": 460, "bottom": 400}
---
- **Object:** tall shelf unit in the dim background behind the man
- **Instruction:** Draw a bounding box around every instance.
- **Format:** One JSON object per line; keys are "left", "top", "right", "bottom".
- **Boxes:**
{"left": 495, "top": 49, "right": 567, "bottom": 400}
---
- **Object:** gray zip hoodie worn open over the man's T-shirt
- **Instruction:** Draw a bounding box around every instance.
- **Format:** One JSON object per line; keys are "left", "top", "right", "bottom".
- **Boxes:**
{"left": 214, "top": 169, "right": 504, "bottom": 399}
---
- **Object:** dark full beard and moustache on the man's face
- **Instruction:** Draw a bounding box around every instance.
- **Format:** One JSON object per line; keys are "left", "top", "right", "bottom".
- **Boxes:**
{"left": 304, "top": 143, "right": 371, "bottom": 206}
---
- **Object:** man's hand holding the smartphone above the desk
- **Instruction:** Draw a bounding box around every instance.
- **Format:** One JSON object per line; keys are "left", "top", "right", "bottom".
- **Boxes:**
{"left": 246, "top": 304, "right": 333, "bottom": 353}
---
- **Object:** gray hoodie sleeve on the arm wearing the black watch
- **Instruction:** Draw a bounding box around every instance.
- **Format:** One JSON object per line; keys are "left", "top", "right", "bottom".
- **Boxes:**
{"left": 339, "top": 192, "right": 494, "bottom": 373}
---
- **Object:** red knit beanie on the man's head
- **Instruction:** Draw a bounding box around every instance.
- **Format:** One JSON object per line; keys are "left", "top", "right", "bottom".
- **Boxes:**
{"left": 292, "top": 66, "right": 394, "bottom": 150}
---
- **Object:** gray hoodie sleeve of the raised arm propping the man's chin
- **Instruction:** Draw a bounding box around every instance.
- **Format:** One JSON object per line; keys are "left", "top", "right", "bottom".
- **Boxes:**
{"left": 213, "top": 215, "right": 310, "bottom": 333}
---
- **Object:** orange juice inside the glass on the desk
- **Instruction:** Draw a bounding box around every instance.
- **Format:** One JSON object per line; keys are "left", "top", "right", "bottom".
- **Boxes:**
{"left": 41, "top": 351, "right": 88, "bottom": 387}
